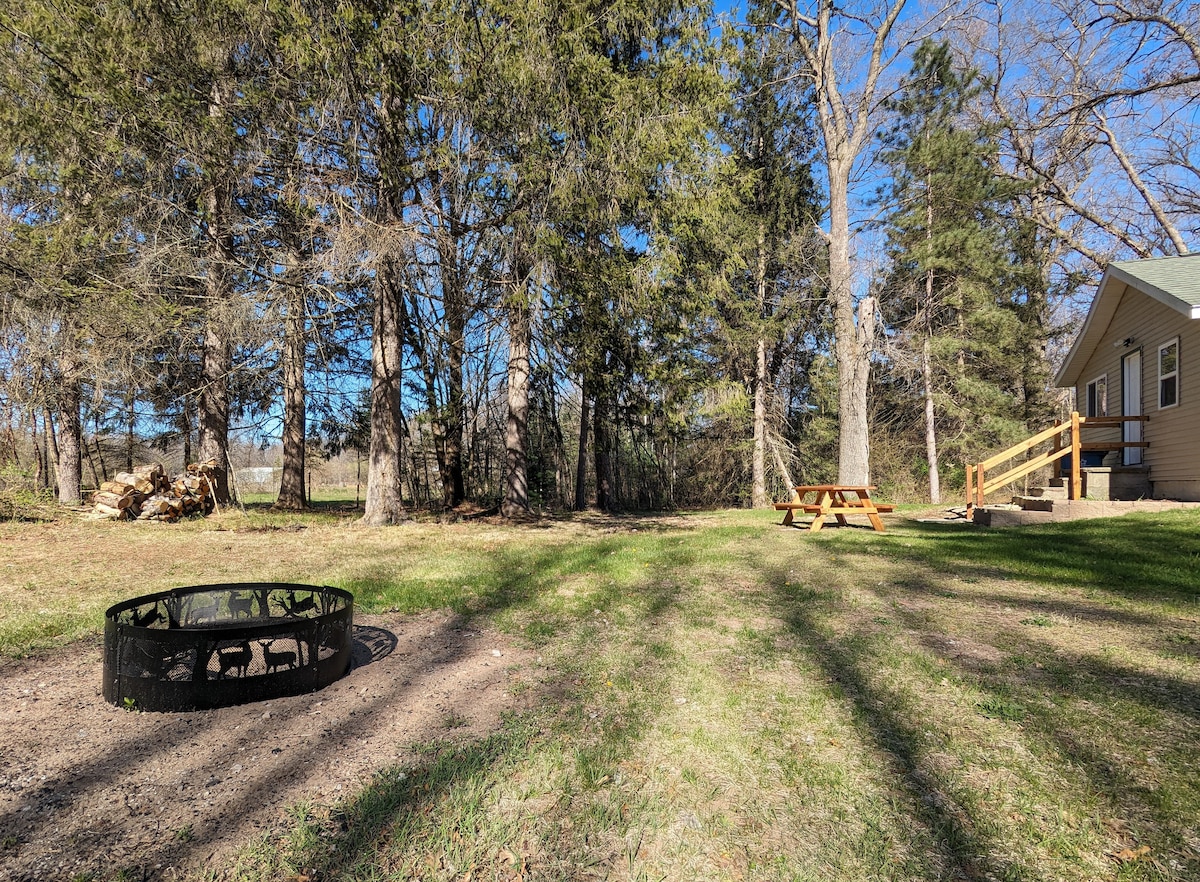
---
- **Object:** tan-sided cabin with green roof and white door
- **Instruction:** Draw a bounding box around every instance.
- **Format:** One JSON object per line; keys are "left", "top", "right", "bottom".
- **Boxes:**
{"left": 1055, "top": 254, "right": 1200, "bottom": 500}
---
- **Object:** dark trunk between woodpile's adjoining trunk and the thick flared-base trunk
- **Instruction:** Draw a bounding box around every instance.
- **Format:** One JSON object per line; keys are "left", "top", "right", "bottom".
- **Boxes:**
{"left": 275, "top": 261, "right": 308, "bottom": 511}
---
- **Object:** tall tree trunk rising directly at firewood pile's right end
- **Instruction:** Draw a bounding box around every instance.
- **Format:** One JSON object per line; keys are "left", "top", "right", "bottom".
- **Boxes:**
{"left": 197, "top": 84, "right": 233, "bottom": 504}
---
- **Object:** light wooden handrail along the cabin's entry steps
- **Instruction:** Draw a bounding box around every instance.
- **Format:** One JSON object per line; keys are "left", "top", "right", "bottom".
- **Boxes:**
{"left": 966, "top": 412, "right": 1150, "bottom": 517}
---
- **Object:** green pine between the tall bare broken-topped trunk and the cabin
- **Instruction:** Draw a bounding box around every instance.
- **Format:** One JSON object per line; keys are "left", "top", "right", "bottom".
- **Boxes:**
{"left": 881, "top": 40, "right": 1028, "bottom": 503}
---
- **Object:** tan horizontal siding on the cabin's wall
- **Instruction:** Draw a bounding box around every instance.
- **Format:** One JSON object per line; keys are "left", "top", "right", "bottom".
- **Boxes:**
{"left": 1076, "top": 288, "right": 1200, "bottom": 494}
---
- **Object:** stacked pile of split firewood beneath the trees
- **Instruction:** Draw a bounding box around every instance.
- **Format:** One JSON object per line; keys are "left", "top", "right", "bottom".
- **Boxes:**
{"left": 88, "top": 461, "right": 216, "bottom": 521}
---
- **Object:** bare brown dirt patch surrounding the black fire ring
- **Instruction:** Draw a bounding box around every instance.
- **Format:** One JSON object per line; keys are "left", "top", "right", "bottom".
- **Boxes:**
{"left": 0, "top": 613, "right": 530, "bottom": 882}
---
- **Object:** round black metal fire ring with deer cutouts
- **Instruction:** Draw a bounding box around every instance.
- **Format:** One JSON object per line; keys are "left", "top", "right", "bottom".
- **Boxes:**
{"left": 104, "top": 582, "right": 354, "bottom": 710}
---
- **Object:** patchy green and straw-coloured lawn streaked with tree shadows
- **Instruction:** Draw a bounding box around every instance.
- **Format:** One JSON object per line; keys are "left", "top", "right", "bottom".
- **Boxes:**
{"left": 0, "top": 509, "right": 1200, "bottom": 882}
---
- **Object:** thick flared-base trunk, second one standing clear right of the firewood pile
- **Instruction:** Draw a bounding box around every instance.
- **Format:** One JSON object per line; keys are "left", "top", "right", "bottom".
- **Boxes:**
{"left": 362, "top": 256, "right": 408, "bottom": 527}
